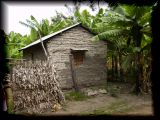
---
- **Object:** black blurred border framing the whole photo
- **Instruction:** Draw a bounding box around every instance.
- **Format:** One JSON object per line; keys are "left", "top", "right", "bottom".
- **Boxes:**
{"left": 0, "top": 0, "right": 160, "bottom": 120}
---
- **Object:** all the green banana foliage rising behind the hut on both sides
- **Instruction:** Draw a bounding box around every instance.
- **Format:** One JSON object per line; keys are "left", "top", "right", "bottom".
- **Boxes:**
{"left": 6, "top": 4, "right": 152, "bottom": 93}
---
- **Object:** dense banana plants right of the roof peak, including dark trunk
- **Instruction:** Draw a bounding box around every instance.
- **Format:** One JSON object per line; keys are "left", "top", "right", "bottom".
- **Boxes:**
{"left": 76, "top": 4, "right": 152, "bottom": 94}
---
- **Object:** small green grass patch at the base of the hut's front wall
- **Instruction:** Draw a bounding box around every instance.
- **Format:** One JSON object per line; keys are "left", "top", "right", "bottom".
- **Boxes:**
{"left": 65, "top": 92, "right": 89, "bottom": 101}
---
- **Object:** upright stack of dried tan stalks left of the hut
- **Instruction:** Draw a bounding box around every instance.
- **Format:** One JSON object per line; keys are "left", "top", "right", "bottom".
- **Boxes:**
{"left": 12, "top": 61, "right": 65, "bottom": 113}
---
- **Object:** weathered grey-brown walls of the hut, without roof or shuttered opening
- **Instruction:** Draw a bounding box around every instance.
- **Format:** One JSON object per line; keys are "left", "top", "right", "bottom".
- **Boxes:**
{"left": 24, "top": 26, "right": 107, "bottom": 88}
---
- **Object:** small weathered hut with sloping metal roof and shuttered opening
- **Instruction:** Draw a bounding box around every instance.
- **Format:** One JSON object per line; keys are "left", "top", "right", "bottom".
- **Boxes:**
{"left": 21, "top": 23, "right": 107, "bottom": 89}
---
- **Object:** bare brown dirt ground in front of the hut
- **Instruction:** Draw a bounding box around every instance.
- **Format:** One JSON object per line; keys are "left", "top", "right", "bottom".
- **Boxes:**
{"left": 45, "top": 94, "right": 152, "bottom": 115}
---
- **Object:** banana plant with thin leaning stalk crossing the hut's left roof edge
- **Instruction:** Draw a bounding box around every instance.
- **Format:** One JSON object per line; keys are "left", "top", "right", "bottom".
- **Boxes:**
{"left": 20, "top": 12, "right": 73, "bottom": 57}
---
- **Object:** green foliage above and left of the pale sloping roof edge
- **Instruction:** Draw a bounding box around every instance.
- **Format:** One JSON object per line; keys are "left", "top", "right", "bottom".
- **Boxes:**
{"left": 6, "top": 9, "right": 75, "bottom": 58}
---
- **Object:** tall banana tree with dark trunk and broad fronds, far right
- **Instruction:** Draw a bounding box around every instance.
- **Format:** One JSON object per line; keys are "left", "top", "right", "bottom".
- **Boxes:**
{"left": 92, "top": 5, "right": 151, "bottom": 94}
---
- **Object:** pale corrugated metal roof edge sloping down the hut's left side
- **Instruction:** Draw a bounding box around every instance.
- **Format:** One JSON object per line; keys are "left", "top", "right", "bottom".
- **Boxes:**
{"left": 19, "top": 23, "right": 81, "bottom": 50}
